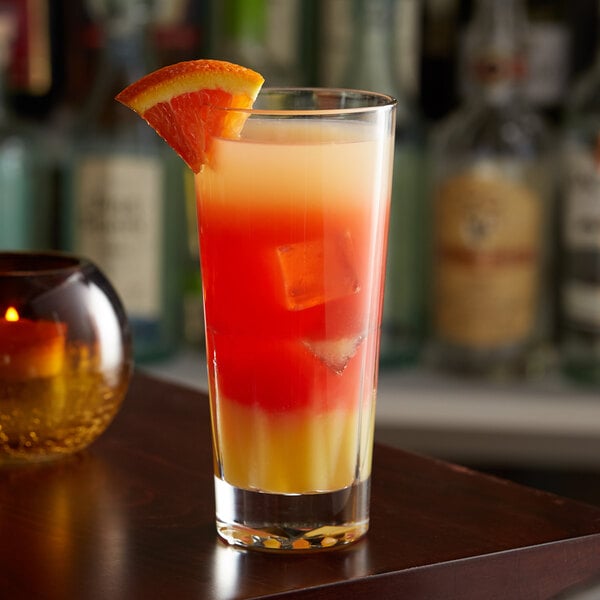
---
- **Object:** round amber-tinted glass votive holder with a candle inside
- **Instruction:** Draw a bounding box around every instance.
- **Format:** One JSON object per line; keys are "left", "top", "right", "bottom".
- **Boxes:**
{"left": 0, "top": 252, "right": 133, "bottom": 464}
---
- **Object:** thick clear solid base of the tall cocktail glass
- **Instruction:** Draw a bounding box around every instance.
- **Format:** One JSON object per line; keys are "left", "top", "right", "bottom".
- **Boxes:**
{"left": 215, "top": 477, "right": 370, "bottom": 552}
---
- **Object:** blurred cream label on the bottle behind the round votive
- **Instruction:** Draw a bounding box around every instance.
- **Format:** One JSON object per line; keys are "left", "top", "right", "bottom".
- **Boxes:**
{"left": 75, "top": 155, "right": 164, "bottom": 319}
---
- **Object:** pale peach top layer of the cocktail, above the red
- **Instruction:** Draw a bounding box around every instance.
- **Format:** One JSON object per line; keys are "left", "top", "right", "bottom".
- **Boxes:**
{"left": 196, "top": 120, "right": 391, "bottom": 207}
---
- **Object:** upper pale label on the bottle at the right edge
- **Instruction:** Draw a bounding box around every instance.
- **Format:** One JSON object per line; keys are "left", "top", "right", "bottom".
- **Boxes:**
{"left": 564, "top": 146, "right": 600, "bottom": 250}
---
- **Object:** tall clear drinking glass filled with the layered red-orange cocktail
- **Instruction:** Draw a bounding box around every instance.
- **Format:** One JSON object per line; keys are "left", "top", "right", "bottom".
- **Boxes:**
{"left": 195, "top": 89, "right": 395, "bottom": 551}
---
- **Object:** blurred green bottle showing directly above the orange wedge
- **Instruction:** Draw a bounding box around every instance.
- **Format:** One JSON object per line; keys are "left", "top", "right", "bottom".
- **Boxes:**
{"left": 211, "top": 0, "right": 301, "bottom": 86}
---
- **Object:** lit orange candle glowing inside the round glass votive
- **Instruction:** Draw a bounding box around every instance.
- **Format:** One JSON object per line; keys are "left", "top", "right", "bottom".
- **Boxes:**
{"left": 0, "top": 306, "right": 67, "bottom": 381}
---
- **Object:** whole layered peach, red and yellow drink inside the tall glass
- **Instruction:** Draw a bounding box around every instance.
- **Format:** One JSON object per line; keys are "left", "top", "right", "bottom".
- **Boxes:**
{"left": 196, "top": 121, "right": 387, "bottom": 493}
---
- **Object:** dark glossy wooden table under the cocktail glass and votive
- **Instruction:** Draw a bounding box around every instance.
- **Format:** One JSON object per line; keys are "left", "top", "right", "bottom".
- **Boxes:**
{"left": 0, "top": 374, "right": 600, "bottom": 600}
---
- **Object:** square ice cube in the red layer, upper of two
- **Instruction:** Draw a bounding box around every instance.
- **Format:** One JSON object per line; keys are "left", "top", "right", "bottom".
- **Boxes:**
{"left": 277, "top": 231, "right": 360, "bottom": 310}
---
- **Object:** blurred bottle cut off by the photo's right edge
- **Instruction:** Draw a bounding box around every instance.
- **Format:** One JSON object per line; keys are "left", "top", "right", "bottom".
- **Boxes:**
{"left": 561, "top": 2, "right": 600, "bottom": 385}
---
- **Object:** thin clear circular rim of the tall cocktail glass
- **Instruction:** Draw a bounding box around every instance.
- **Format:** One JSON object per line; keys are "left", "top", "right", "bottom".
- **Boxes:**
{"left": 223, "top": 86, "right": 398, "bottom": 117}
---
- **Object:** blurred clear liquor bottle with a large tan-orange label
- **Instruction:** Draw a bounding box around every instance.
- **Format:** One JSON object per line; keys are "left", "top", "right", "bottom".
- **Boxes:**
{"left": 431, "top": 0, "right": 553, "bottom": 377}
